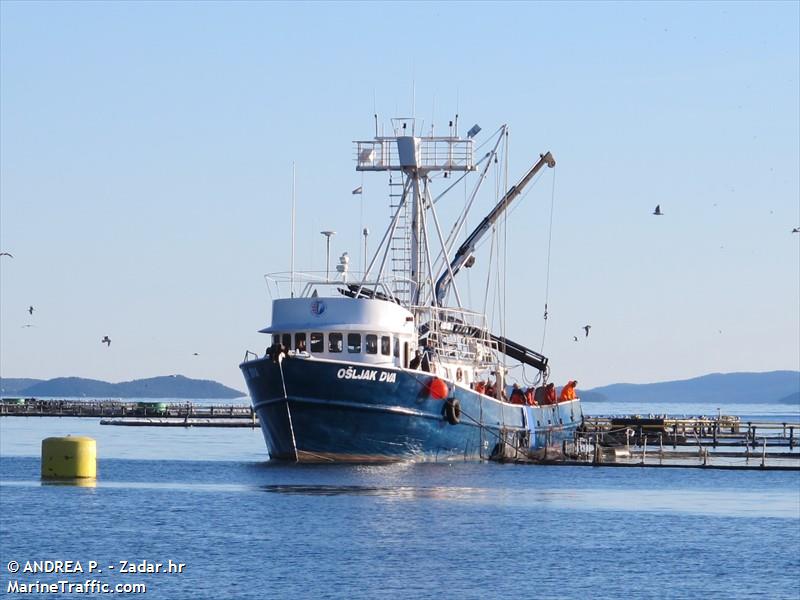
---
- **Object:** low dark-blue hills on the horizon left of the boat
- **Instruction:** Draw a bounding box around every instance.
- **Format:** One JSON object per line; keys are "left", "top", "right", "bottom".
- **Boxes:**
{"left": 1, "top": 375, "right": 246, "bottom": 400}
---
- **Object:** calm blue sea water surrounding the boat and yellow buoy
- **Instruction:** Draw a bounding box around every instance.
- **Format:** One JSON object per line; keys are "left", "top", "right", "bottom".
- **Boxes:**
{"left": 0, "top": 405, "right": 800, "bottom": 600}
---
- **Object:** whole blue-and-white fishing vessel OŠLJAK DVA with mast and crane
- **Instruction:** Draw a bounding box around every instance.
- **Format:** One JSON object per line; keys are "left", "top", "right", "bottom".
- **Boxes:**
{"left": 240, "top": 117, "right": 583, "bottom": 462}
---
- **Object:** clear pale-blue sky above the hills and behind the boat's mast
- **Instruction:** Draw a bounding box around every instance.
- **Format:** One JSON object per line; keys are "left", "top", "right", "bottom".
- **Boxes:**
{"left": 0, "top": 2, "right": 800, "bottom": 389}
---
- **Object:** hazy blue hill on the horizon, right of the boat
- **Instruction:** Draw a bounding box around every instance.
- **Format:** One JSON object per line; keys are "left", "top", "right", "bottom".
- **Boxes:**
{"left": 580, "top": 371, "right": 800, "bottom": 404}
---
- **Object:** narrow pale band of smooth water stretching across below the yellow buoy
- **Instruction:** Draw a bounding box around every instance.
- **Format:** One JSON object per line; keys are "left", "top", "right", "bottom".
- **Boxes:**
{"left": 0, "top": 474, "right": 800, "bottom": 521}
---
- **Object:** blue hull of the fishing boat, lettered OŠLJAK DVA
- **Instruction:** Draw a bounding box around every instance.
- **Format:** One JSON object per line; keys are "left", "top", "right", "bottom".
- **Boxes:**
{"left": 240, "top": 357, "right": 583, "bottom": 462}
